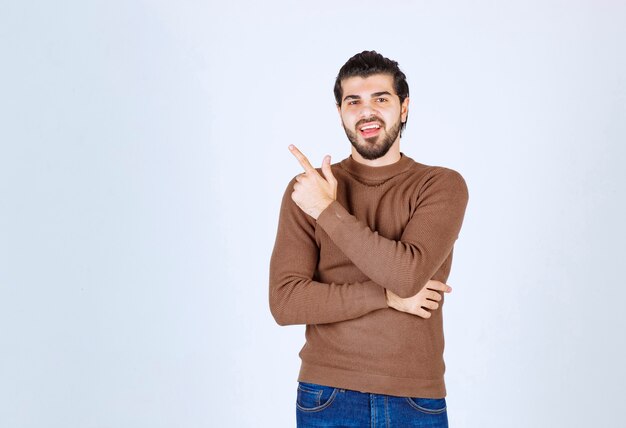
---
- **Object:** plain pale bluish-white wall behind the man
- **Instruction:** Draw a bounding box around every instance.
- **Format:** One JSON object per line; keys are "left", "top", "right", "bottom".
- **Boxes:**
{"left": 0, "top": 0, "right": 626, "bottom": 428}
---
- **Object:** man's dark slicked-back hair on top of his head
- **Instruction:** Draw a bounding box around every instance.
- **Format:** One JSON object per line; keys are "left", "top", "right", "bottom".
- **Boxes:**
{"left": 334, "top": 51, "right": 409, "bottom": 132}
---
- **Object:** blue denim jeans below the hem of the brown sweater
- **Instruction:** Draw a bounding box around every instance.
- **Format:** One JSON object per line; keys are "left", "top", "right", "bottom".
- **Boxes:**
{"left": 296, "top": 382, "right": 448, "bottom": 428}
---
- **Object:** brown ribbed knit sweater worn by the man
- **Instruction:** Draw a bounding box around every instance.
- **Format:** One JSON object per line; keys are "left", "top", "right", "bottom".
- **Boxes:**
{"left": 269, "top": 155, "right": 468, "bottom": 398}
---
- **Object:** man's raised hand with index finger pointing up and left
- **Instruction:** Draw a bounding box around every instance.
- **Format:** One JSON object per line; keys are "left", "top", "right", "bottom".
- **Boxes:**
{"left": 289, "top": 144, "right": 337, "bottom": 220}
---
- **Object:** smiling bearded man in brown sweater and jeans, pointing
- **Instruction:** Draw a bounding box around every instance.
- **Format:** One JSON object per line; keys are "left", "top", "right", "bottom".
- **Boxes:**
{"left": 269, "top": 51, "right": 468, "bottom": 427}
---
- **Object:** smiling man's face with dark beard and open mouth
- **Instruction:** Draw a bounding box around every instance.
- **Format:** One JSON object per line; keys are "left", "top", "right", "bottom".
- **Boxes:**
{"left": 338, "top": 74, "right": 409, "bottom": 160}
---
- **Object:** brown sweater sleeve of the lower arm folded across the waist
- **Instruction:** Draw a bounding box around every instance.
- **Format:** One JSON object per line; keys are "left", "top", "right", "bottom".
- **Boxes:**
{"left": 269, "top": 176, "right": 387, "bottom": 325}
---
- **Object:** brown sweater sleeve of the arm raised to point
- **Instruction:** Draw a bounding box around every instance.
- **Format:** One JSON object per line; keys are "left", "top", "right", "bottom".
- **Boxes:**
{"left": 317, "top": 167, "right": 468, "bottom": 298}
